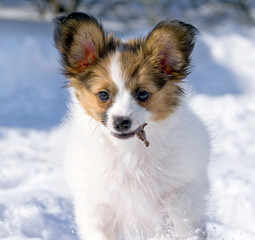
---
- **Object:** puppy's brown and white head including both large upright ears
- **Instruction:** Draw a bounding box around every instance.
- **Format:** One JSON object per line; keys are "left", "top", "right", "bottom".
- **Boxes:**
{"left": 54, "top": 13, "right": 197, "bottom": 138}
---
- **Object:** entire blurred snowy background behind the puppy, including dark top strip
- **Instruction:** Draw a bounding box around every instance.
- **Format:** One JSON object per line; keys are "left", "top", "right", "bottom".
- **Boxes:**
{"left": 0, "top": 0, "right": 255, "bottom": 240}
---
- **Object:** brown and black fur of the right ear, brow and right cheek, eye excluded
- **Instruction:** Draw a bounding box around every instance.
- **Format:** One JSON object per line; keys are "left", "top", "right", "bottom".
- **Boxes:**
{"left": 115, "top": 20, "right": 197, "bottom": 121}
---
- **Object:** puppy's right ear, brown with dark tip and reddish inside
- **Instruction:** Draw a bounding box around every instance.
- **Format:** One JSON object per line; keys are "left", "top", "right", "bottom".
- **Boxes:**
{"left": 144, "top": 20, "right": 198, "bottom": 80}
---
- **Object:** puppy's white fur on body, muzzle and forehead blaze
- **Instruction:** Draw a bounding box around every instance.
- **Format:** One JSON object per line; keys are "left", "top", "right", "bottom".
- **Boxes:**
{"left": 65, "top": 53, "right": 210, "bottom": 240}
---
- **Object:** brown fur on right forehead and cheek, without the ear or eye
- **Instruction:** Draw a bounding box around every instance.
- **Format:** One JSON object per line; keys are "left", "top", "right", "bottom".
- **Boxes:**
{"left": 120, "top": 49, "right": 182, "bottom": 121}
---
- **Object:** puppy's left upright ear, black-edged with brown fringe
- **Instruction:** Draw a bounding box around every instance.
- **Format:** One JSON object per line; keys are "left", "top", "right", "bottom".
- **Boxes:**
{"left": 53, "top": 12, "right": 105, "bottom": 76}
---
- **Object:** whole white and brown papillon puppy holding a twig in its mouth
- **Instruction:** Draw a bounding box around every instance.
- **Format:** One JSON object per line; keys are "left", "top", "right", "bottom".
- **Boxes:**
{"left": 54, "top": 12, "right": 210, "bottom": 240}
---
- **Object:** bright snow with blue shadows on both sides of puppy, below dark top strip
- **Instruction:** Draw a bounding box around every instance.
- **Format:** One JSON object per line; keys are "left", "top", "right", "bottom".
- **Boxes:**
{"left": 0, "top": 16, "right": 255, "bottom": 240}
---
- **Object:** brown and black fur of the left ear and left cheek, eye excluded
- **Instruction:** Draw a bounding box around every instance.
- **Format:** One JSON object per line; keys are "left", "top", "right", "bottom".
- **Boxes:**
{"left": 54, "top": 13, "right": 119, "bottom": 122}
